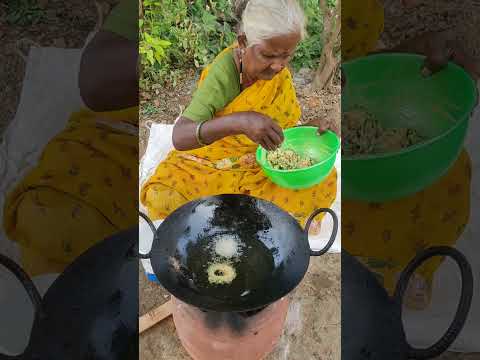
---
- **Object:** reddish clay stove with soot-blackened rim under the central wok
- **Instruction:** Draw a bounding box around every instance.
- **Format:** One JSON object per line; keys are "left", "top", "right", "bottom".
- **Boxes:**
{"left": 173, "top": 297, "right": 290, "bottom": 360}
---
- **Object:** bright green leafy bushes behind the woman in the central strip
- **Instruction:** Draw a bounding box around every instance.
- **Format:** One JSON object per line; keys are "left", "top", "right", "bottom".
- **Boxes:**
{"left": 139, "top": 0, "right": 335, "bottom": 90}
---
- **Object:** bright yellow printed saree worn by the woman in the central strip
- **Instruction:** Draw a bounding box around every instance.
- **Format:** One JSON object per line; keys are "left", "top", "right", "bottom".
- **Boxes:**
{"left": 141, "top": 49, "right": 337, "bottom": 226}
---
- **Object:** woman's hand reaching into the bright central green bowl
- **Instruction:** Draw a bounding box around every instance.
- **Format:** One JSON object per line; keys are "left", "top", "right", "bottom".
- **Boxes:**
{"left": 240, "top": 111, "right": 284, "bottom": 151}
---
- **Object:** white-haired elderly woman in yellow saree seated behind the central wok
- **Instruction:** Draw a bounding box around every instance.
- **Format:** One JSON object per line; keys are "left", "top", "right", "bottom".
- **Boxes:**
{"left": 141, "top": 0, "right": 337, "bottom": 231}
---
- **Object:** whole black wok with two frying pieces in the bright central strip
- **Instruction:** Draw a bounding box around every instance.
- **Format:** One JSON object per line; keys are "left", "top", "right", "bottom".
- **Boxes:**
{"left": 140, "top": 194, "right": 338, "bottom": 312}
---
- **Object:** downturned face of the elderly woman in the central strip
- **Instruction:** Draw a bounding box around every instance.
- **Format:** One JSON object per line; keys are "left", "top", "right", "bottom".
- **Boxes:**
{"left": 239, "top": 33, "right": 301, "bottom": 80}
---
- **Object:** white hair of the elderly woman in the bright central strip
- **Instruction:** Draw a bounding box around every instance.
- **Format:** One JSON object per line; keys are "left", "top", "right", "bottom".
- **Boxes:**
{"left": 241, "top": 0, "right": 306, "bottom": 46}
